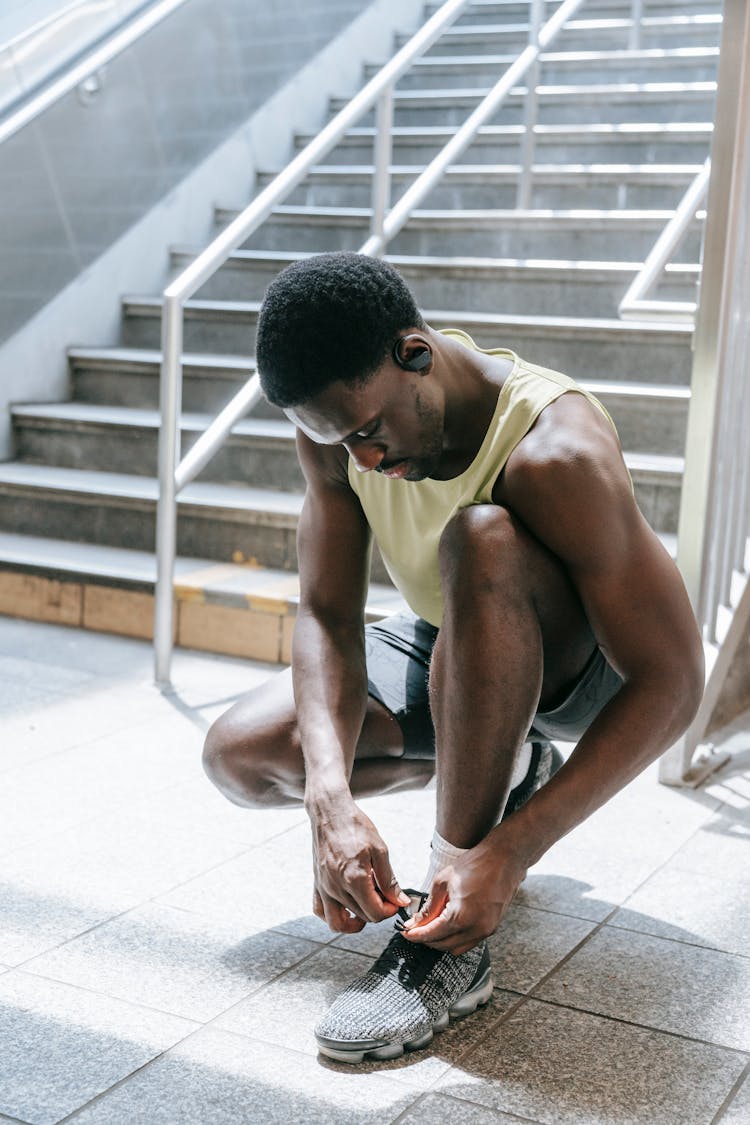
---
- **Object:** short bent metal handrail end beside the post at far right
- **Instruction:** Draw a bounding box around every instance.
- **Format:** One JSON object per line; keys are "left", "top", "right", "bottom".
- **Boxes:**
{"left": 618, "top": 159, "right": 711, "bottom": 322}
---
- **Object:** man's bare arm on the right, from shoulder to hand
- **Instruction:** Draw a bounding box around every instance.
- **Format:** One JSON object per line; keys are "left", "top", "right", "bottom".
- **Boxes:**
{"left": 409, "top": 395, "right": 703, "bottom": 953}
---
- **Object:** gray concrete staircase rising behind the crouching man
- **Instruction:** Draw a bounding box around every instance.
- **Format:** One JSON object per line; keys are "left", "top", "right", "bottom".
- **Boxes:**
{"left": 0, "top": 0, "right": 721, "bottom": 660}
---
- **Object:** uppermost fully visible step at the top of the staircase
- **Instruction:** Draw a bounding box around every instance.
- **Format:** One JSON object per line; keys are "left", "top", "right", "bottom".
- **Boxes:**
{"left": 396, "top": 9, "right": 722, "bottom": 57}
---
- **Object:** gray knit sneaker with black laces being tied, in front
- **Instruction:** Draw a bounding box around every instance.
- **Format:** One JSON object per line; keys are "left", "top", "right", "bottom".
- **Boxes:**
{"left": 315, "top": 918, "right": 493, "bottom": 1063}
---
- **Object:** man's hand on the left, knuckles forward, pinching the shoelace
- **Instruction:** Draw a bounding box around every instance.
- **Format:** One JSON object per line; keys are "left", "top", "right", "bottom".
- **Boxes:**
{"left": 313, "top": 801, "right": 409, "bottom": 934}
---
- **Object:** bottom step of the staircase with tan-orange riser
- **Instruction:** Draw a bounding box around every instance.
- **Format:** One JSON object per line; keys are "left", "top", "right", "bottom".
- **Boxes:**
{"left": 0, "top": 532, "right": 404, "bottom": 664}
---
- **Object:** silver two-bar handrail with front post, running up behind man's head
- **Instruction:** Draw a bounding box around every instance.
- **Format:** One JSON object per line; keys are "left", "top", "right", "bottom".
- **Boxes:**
{"left": 154, "top": 0, "right": 585, "bottom": 685}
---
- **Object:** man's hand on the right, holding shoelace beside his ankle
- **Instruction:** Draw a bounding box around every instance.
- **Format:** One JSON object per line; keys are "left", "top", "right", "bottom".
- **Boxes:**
{"left": 404, "top": 829, "right": 527, "bottom": 956}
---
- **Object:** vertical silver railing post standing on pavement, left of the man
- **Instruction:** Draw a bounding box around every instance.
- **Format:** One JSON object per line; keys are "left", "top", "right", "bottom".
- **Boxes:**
{"left": 154, "top": 295, "right": 182, "bottom": 686}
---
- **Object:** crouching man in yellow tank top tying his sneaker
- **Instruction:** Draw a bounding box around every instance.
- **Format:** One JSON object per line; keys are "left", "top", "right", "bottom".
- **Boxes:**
{"left": 205, "top": 254, "right": 703, "bottom": 1062}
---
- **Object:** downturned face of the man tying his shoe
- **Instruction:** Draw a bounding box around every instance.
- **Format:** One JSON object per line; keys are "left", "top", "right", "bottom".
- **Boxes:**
{"left": 284, "top": 360, "right": 444, "bottom": 480}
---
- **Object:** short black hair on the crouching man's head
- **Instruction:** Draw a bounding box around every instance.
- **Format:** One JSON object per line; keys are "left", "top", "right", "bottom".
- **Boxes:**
{"left": 255, "top": 252, "right": 425, "bottom": 407}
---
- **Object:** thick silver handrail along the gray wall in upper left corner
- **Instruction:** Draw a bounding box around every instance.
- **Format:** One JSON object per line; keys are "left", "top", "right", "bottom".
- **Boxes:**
{"left": 0, "top": 0, "right": 188, "bottom": 144}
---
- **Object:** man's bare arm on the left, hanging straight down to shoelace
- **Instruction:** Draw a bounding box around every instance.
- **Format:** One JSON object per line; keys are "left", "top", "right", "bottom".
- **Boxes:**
{"left": 292, "top": 433, "right": 407, "bottom": 932}
